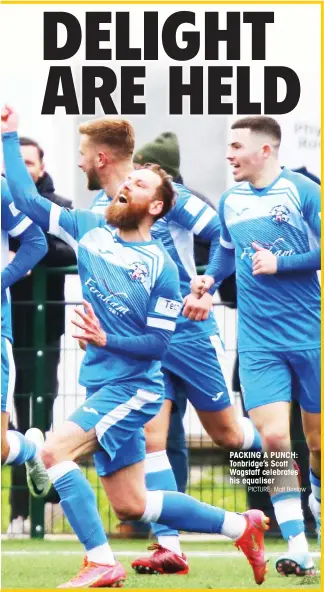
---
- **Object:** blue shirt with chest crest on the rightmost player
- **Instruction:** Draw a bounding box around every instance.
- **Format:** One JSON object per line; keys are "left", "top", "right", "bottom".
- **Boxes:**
{"left": 215, "top": 168, "right": 320, "bottom": 352}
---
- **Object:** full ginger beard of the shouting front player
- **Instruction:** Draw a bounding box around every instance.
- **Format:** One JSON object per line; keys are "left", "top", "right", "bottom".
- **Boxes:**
{"left": 106, "top": 192, "right": 148, "bottom": 230}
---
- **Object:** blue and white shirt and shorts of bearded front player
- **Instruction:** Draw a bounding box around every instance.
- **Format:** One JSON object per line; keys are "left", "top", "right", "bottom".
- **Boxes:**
{"left": 4, "top": 133, "right": 182, "bottom": 474}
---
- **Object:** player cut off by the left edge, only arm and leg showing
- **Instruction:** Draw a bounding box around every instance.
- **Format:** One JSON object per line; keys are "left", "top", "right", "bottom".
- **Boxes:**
{"left": 1, "top": 177, "right": 49, "bottom": 494}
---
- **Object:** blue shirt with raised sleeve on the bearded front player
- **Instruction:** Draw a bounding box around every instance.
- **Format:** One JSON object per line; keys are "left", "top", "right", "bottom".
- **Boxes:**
{"left": 4, "top": 134, "right": 182, "bottom": 393}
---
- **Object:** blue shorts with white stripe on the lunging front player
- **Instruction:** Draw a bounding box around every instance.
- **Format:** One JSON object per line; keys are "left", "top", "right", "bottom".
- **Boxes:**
{"left": 68, "top": 385, "right": 164, "bottom": 476}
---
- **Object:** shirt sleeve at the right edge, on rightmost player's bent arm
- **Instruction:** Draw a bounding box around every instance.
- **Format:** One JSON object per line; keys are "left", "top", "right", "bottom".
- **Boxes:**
{"left": 277, "top": 179, "right": 321, "bottom": 273}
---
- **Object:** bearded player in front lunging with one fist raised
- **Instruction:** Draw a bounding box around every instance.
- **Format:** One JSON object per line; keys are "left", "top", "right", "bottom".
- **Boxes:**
{"left": 2, "top": 109, "right": 267, "bottom": 587}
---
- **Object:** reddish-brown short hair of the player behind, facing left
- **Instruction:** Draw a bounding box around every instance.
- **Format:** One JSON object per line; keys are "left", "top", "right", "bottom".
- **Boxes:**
{"left": 79, "top": 117, "right": 135, "bottom": 159}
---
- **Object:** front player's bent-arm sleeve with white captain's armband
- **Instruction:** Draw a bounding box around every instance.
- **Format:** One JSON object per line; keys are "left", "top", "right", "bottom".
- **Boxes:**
{"left": 106, "top": 261, "right": 182, "bottom": 360}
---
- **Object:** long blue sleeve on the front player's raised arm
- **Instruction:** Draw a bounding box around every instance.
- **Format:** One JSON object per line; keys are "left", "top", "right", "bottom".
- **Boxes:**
{"left": 2, "top": 132, "right": 104, "bottom": 249}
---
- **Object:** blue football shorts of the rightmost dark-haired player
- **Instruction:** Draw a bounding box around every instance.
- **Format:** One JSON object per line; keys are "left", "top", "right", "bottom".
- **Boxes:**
{"left": 239, "top": 348, "right": 321, "bottom": 413}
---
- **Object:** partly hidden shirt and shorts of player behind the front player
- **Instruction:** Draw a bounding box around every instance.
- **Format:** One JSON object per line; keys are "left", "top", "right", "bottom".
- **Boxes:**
{"left": 92, "top": 183, "right": 231, "bottom": 411}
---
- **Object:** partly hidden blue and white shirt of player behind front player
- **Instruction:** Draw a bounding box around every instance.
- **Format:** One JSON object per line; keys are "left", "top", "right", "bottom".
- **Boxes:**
{"left": 91, "top": 183, "right": 220, "bottom": 342}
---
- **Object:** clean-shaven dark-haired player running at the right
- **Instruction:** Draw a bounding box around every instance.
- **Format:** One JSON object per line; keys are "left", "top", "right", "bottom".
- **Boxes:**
{"left": 189, "top": 117, "right": 321, "bottom": 575}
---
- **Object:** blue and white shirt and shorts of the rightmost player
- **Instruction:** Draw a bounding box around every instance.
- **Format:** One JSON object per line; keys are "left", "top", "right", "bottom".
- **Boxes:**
{"left": 210, "top": 168, "right": 321, "bottom": 413}
